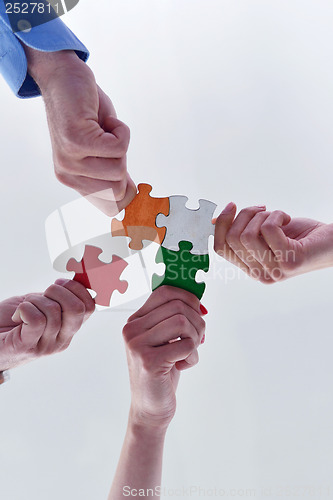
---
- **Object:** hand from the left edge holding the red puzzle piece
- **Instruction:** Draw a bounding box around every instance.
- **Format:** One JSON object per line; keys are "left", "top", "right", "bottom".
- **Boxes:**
{"left": 0, "top": 280, "right": 95, "bottom": 371}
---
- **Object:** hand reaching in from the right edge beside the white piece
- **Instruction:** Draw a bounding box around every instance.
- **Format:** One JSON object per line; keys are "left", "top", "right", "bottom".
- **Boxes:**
{"left": 214, "top": 203, "right": 333, "bottom": 283}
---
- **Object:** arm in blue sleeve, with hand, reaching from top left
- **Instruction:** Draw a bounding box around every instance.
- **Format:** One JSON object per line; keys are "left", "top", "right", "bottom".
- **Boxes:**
{"left": 0, "top": 5, "right": 136, "bottom": 216}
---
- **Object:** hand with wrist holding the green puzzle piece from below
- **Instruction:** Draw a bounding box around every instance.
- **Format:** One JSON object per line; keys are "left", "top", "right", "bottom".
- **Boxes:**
{"left": 123, "top": 286, "right": 205, "bottom": 429}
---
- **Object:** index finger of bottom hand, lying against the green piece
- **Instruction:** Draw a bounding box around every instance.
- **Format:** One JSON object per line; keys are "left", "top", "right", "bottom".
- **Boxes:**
{"left": 128, "top": 285, "right": 201, "bottom": 321}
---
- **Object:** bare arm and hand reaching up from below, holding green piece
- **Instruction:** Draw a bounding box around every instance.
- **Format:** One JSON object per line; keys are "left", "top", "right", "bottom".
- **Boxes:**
{"left": 109, "top": 286, "right": 205, "bottom": 500}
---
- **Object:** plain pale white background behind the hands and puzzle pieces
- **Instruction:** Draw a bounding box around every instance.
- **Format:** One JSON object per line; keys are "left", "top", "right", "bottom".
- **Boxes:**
{"left": 0, "top": 0, "right": 333, "bottom": 500}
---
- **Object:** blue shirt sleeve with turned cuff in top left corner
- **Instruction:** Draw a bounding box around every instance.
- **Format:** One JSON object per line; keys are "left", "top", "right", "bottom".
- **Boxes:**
{"left": 0, "top": 0, "right": 89, "bottom": 98}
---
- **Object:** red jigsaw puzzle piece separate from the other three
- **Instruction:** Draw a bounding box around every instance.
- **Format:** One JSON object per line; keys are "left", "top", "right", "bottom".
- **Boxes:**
{"left": 66, "top": 245, "right": 128, "bottom": 307}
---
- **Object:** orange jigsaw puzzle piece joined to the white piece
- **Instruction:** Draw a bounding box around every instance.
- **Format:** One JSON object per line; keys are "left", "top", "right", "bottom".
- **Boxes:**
{"left": 111, "top": 184, "right": 170, "bottom": 250}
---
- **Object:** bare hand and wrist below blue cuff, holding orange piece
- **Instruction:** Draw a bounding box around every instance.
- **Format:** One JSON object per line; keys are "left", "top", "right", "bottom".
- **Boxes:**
{"left": 25, "top": 47, "right": 136, "bottom": 216}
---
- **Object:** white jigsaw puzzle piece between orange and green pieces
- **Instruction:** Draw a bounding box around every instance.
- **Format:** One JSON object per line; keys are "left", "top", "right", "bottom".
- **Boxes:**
{"left": 156, "top": 196, "right": 217, "bottom": 255}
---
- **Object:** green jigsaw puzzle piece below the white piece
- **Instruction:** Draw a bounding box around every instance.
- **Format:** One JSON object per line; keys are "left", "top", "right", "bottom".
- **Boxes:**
{"left": 152, "top": 241, "right": 209, "bottom": 300}
